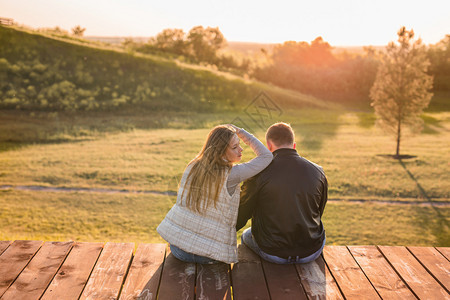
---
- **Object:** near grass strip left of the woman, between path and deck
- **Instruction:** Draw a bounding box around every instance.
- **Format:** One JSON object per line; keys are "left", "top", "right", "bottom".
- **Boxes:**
{"left": 0, "top": 191, "right": 175, "bottom": 242}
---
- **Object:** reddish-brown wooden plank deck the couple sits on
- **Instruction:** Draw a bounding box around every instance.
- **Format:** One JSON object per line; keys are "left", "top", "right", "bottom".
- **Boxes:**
{"left": 0, "top": 241, "right": 450, "bottom": 300}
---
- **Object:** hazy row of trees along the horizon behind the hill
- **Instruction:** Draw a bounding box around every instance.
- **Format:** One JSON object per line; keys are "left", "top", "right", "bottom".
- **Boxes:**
{"left": 124, "top": 26, "right": 450, "bottom": 105}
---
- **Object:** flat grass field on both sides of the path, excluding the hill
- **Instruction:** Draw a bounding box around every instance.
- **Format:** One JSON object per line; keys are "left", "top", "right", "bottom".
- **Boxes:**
{"left": 0, "top": 108, "right": 450, "bottom": 246}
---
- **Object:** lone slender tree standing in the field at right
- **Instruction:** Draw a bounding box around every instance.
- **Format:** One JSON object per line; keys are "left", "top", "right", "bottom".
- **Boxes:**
{"left": 370, "top": 27, "right": 433, "bottom": 158}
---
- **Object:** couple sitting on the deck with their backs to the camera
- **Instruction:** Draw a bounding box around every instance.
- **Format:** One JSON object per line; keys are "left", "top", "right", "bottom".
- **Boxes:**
{"left": 157, "top": 123, "right": 328, "bottom": 264}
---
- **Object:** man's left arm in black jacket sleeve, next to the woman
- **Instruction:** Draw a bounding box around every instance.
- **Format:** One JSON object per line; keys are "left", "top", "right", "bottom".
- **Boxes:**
{"left": 236, "top": 176, "right": 258, "bottom": 230}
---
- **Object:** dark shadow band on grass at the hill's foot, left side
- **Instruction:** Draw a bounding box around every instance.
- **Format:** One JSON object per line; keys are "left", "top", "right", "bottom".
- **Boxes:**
{"left": 0, "top": 110, "right": 212, "bottom": 153}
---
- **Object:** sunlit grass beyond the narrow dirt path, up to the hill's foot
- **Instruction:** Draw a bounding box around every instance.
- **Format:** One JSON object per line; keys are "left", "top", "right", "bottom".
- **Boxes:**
{"left": 0, "top": 109, "right": 450, "bottom": 201}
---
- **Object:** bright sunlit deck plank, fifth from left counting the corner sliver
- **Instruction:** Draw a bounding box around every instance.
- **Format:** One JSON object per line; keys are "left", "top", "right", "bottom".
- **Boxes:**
{"left": 80, "top": 243, "right": 134, "bottom": 299}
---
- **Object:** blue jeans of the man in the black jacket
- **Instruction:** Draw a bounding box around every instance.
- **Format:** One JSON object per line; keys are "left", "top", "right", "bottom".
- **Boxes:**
{"left": 241, "top": 227, "right": 325, "bottom": 264}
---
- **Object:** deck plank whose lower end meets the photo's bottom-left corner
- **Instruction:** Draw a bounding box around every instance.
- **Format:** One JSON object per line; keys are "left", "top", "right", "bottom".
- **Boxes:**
{"left": 2, "top": 242, "right": 73, "bottom": 300}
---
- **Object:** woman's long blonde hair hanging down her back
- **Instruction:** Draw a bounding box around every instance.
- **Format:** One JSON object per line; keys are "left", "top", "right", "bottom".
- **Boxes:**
{"left": 183, "top": 125, "right": 236, "bottom": 212}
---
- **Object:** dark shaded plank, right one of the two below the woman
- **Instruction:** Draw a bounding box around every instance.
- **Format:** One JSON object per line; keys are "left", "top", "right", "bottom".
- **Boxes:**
{"left": 195, "top": 263, "right": 231, "bottom": 300}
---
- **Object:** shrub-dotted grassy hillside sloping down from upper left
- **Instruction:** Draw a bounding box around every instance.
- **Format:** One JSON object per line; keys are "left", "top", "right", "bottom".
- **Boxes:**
{"left": 0, "top": 26, "right": 326, "bottom": 112}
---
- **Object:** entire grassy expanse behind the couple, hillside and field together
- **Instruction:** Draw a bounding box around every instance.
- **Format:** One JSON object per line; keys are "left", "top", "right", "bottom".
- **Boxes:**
{"left": 0, "top": 27, "right": 450, "bottom": 246}
